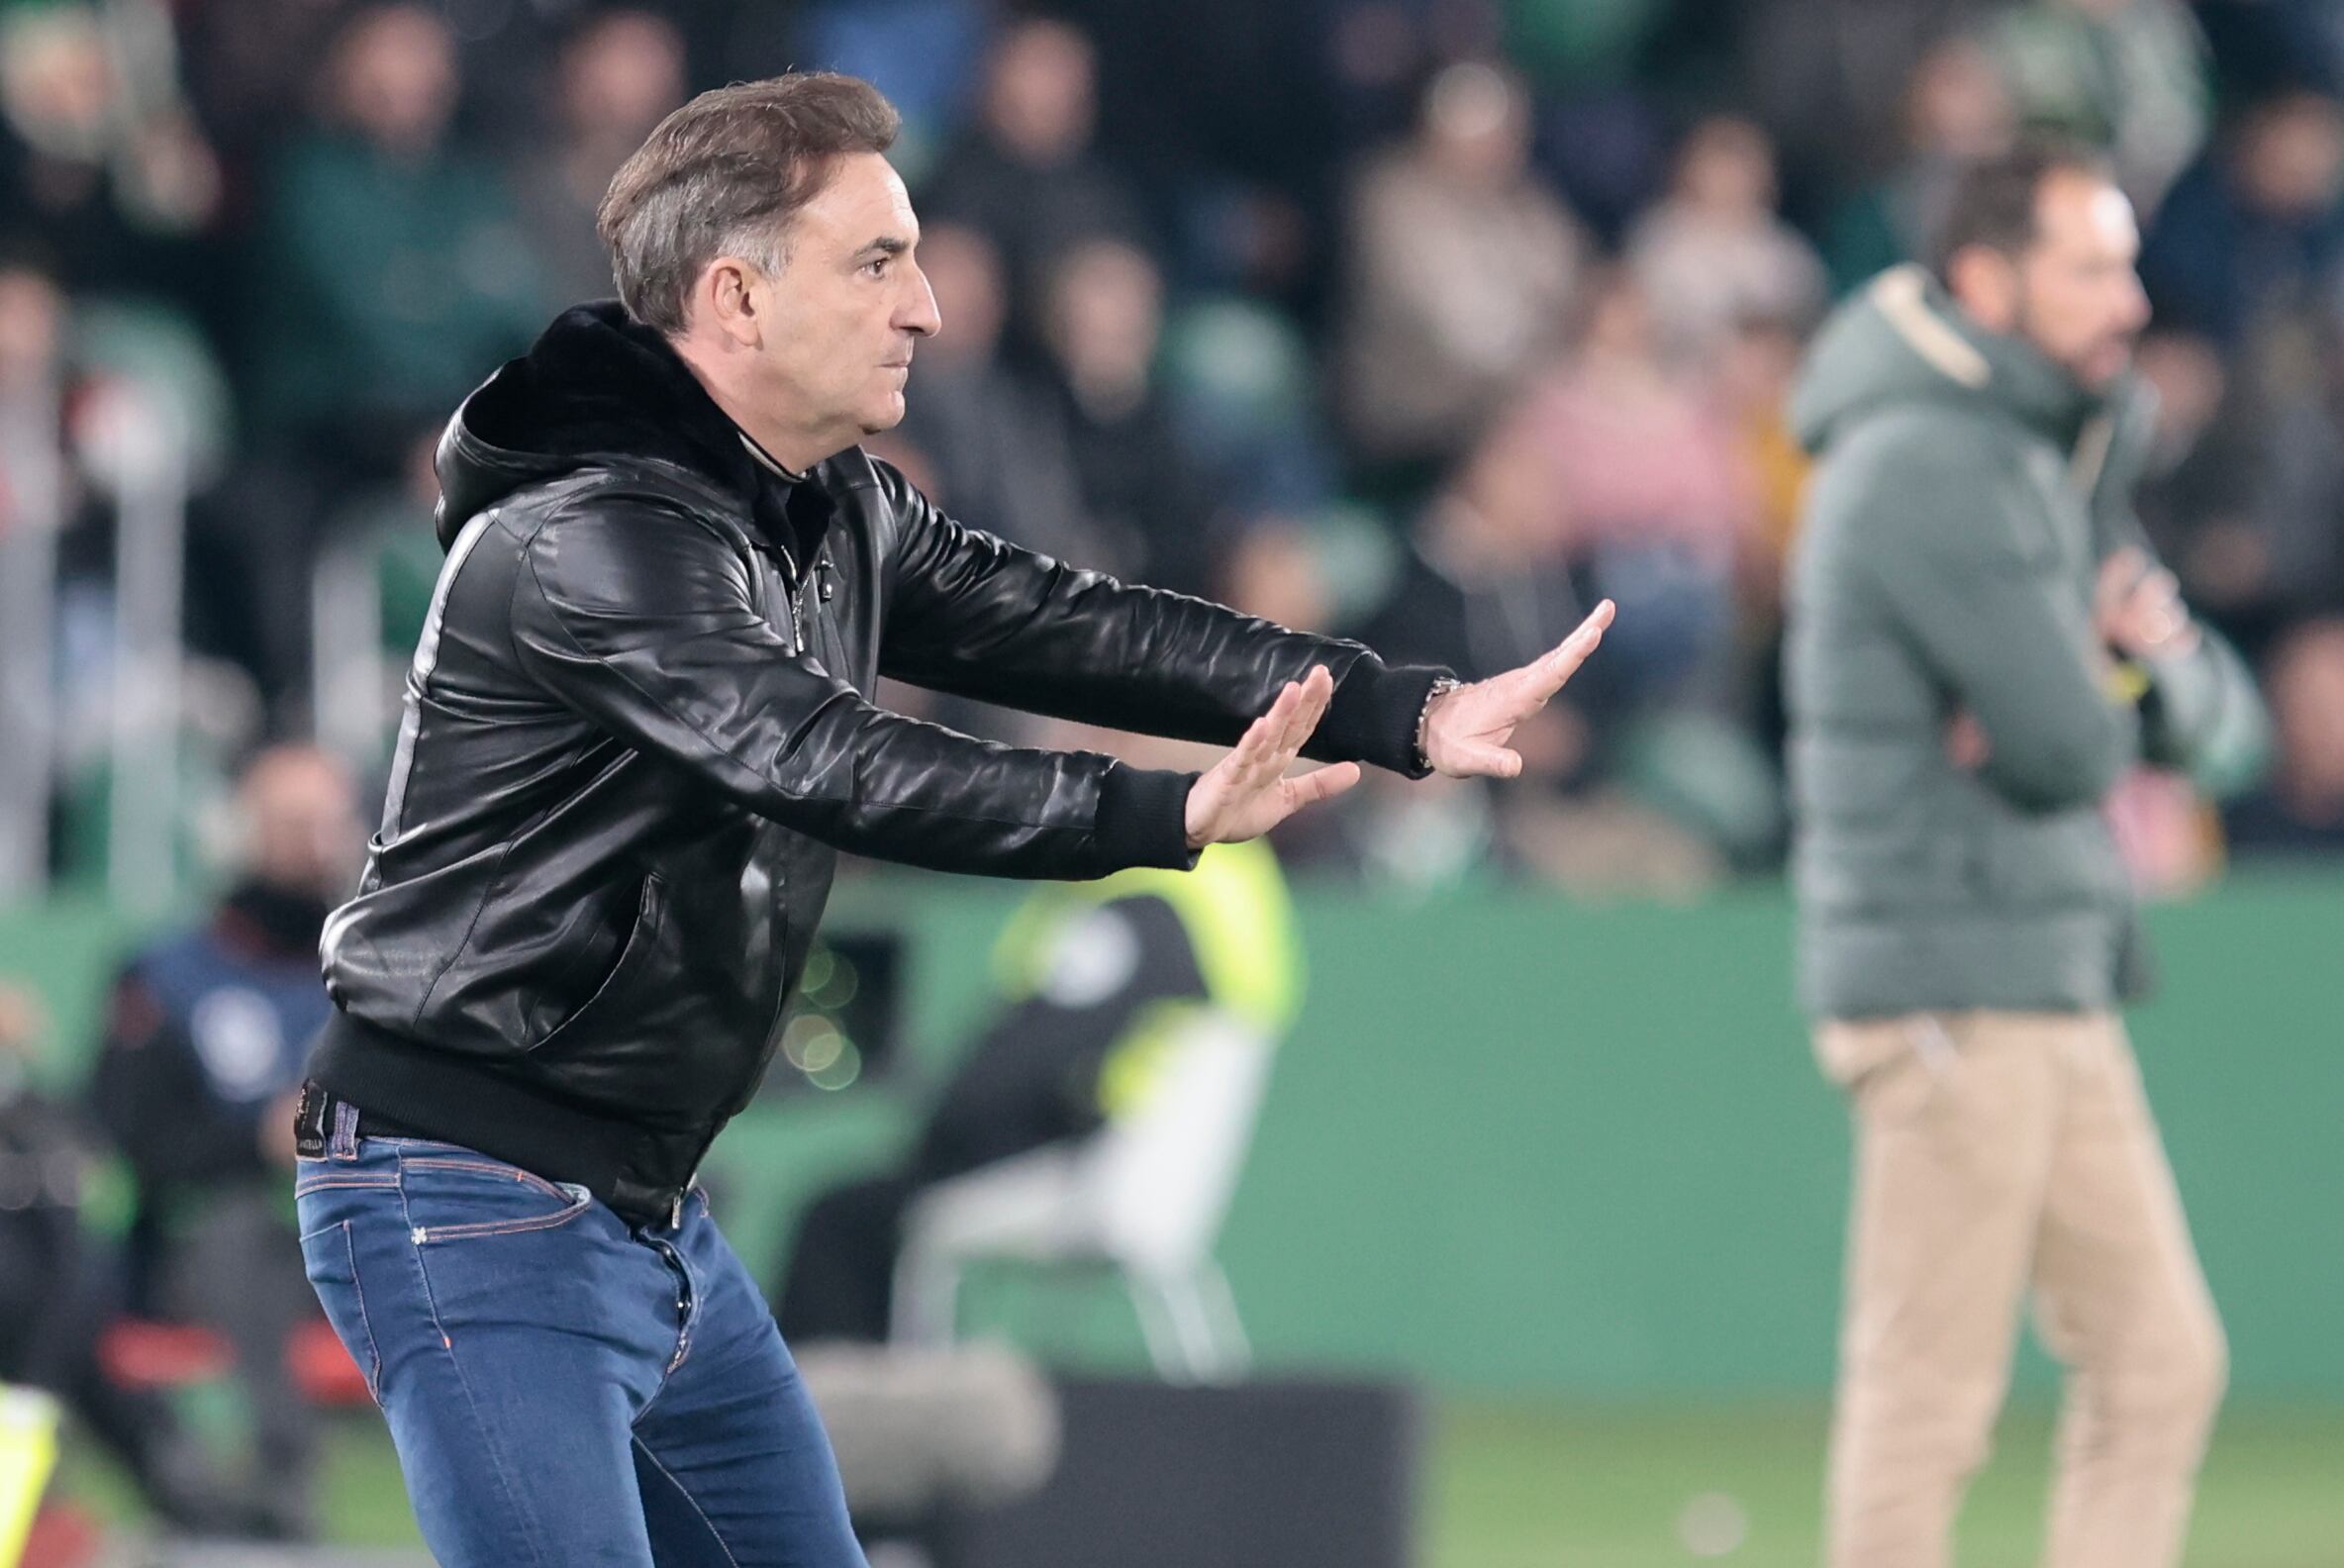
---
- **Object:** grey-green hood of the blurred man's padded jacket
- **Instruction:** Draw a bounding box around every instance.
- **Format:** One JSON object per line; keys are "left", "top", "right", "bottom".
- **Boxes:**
{"left": 1791, "top": 267, "right": 2102, "bottom": 452}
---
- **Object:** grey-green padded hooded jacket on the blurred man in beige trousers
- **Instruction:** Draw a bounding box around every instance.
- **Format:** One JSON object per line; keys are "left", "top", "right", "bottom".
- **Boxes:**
{"left": 1784, "top": 267, "right": 2262, "bottom": 1018}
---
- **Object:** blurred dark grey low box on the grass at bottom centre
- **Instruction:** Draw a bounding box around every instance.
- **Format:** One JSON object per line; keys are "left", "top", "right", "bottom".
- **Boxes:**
{"left": 937, "top": 1381, "right": 1422, "bottom": 1568}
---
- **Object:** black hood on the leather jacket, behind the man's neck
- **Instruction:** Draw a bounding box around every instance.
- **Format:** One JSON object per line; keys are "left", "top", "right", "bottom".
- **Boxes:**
{"left": 434, "top": 300, "right": 757, "bottom": 548}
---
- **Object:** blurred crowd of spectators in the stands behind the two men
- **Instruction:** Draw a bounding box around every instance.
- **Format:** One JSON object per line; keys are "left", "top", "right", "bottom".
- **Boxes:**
{"left": 0, "top": 0, "right": 2344, "bottom": 893}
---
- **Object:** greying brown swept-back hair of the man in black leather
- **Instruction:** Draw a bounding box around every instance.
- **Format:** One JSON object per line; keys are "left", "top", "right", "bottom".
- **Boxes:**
{"left": 595, "top": 70, "right": 903, "bottom": 333}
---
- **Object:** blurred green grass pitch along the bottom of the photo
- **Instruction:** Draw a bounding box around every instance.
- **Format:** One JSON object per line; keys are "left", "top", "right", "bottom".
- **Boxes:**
{"left": 63, "top": 1402, "right": 2344, "bottom": 1568}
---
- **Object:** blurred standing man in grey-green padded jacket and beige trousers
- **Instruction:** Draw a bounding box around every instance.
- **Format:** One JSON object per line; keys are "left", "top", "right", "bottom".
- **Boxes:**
{"left": 1786, "top": 147, "right": 2262, "bottom": 1568}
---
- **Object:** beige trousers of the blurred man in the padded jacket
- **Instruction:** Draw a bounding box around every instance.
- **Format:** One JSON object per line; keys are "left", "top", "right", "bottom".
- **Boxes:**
{"left": 1814, "top": 1013, "right": 2227, "bottom": 1568}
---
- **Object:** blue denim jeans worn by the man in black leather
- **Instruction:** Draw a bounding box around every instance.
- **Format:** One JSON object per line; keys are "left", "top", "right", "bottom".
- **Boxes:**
{"left": 295, "top": 1111, "right": 865, "bottom": 1568}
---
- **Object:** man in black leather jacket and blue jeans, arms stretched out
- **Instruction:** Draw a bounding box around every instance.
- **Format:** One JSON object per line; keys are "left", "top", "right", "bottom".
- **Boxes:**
{"left": 298, "top": 75, "right": 1608, "bottom": 1568}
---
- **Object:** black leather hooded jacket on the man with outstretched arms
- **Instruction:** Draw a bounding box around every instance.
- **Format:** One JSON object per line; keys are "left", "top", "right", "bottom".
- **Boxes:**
{"left": 312, "top": 305, "right": 1437, "bottom": 1219}
